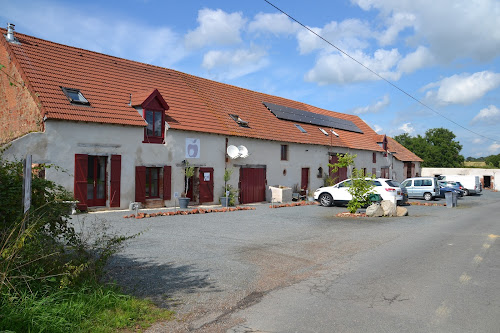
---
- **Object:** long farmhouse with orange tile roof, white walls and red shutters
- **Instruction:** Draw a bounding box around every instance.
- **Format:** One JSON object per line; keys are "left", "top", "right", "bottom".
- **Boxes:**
{"left": 0, "top": 29, "right": 422, "bottom": 209}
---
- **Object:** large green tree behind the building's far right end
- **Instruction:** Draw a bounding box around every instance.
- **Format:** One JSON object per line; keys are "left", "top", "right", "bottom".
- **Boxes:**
{"left": 394, "top": 128, "right": 464, "bottom": 168}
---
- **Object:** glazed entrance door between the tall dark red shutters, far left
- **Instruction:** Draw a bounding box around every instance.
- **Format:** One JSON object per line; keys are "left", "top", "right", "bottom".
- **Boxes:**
{"left": 87, "top": 155, "right": 106, "bottom": 207}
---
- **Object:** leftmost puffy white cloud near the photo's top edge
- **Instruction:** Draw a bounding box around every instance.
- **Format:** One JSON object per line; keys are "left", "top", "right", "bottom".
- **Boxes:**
{"left": 185, "top": 8, "right": 246, "bottom": 49}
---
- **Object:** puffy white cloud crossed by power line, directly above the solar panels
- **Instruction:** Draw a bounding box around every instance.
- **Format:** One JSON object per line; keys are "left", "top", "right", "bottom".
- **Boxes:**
{"left": 305, "top": 49, "right": 401, "bottom": 85}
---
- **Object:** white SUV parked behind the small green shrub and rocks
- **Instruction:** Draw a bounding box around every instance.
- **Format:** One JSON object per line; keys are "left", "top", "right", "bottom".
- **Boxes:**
{"left": 314, "top": 178, "right": 403, "bottom": 207}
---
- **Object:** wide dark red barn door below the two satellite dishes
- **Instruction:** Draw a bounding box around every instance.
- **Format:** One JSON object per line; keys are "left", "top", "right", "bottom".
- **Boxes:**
{"left": 239, "top": 168, "right": 266, "bottom": 204}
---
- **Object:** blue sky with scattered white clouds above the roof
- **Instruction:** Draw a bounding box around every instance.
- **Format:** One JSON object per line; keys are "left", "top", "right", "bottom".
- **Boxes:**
{"left": 0, "top": 0, "right": 500, "bottom": 157}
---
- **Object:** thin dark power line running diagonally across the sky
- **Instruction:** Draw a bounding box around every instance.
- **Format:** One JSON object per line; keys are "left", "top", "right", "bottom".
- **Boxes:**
{"left": 264, "top": 0, "right": 497, "bottom": 141}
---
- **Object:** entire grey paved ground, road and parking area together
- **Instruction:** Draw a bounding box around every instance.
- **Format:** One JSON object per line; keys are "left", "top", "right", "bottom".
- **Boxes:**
{"left": 75, "top": 191, "right": 500, "bottom": 333}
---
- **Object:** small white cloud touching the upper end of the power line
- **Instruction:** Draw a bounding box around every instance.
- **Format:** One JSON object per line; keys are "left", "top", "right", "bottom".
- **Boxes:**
{"left": 248, "top": 13, "right": 300, "bottom": 35}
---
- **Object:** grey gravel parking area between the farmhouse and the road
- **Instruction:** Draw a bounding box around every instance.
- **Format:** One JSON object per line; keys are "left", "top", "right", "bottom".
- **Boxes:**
{"left": 73, "top": 191, "right": 500, "bottom": 332}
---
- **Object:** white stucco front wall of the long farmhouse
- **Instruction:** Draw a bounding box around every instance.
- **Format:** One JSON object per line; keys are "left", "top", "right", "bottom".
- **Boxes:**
{"left": 4, "top": 121, "right": 414, "bottom": 208}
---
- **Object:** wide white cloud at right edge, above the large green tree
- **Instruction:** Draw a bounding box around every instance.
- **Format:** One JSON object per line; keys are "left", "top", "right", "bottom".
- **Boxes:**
{"left": 423, "top": 71, "right": 500, "bottom": 105}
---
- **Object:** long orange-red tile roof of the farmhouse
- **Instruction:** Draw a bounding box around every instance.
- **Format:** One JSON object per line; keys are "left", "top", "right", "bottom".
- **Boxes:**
{"left": 0, "top": 29, "right": 418, "bottom": 156}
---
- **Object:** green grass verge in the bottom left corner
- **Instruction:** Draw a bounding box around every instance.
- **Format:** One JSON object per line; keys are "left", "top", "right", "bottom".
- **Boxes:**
{"left": 0, "top": 284, "right": 173, "bottom": 333}
